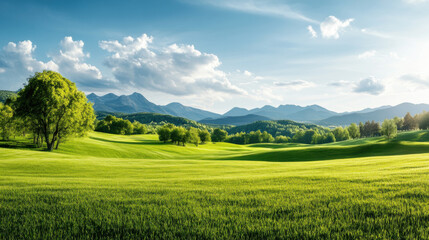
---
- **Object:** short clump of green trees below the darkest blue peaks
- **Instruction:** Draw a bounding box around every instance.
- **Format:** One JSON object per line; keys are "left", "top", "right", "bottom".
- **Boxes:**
{"left": 95, "top": 115, "right": 148, "bottom": 135}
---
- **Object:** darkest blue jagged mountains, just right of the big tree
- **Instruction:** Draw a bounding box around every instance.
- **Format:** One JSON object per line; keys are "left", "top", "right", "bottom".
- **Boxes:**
{"left": 87, "top": 93, "right": 221, "bottom": 121}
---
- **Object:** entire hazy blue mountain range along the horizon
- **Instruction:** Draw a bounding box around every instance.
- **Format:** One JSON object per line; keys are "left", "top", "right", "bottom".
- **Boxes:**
{"left": 87, "top": 93, "right": 429, "bottom": 126}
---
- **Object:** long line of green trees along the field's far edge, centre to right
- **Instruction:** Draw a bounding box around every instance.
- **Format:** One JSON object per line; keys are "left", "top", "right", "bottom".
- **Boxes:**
{"left": 151, "top": 112, "right": 429, "bottom": 145}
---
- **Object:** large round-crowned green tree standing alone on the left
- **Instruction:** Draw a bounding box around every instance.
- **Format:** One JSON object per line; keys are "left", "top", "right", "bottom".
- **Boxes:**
{"left": 15, "top": 71, "right": 95, "bottom": 151}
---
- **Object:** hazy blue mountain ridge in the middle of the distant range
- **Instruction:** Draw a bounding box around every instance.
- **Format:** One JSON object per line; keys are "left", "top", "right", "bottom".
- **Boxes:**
{"left": 224, "top": 105, "right": 338, "bottom": 122}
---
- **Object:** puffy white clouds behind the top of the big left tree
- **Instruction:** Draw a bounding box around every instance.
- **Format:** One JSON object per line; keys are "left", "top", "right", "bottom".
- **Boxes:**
{"left": 0, "top": 37, "right": 106, "bottom": 89}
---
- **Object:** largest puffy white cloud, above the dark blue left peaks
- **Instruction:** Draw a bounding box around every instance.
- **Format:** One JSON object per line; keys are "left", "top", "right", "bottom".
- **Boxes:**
{"left": 99, "top": 34, "right": 242, "bottom": 95}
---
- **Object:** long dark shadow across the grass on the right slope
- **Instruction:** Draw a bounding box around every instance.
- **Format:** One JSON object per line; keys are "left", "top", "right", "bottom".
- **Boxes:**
{"left": 222, "top": 141, "right": 429, "bottom": 162}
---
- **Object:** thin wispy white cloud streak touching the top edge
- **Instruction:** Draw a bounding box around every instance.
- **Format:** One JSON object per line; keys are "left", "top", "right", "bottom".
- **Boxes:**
{"left": 186, "top": 0, "right": 317, "bottom": 23}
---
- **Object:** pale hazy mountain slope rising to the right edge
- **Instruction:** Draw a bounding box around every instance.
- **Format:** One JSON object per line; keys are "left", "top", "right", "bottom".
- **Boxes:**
{"left": 315, "top": 103, "right": 429, "bottom": 126}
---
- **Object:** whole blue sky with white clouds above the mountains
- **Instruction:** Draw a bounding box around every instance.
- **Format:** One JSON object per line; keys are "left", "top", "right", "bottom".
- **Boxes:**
{"left": 0, "top": 0, "right": 429, "bottom": 113}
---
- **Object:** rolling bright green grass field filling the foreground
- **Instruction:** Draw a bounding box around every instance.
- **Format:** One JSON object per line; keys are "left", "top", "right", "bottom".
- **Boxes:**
{"left": 0, "top": 131, "right": 429, "bottom": 239}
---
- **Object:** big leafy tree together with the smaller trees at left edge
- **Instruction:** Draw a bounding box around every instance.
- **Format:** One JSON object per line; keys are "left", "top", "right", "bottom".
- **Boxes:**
{"left": 0, "top": 71, "right": 95, "bottom": 151}
